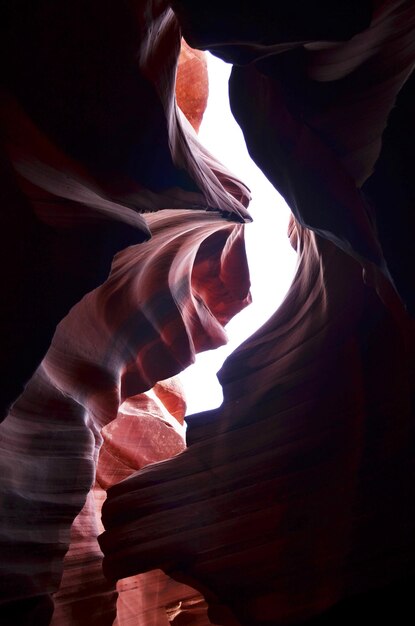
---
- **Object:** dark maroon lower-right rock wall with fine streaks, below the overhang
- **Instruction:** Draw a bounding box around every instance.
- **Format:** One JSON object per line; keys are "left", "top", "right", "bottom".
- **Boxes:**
{"left": 100, "top": 219, "right": 415, "bottom": 626}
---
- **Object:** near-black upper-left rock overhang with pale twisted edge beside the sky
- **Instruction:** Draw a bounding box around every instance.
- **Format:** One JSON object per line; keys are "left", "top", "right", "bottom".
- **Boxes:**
{"left": 0, "top": 0, "right": 249, "bottom": 419}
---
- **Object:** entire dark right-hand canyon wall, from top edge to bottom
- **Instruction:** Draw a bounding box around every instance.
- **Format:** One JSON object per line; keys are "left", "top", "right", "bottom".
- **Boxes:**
{"left": 101, "top": 0, "right": 415, "bottom": 626}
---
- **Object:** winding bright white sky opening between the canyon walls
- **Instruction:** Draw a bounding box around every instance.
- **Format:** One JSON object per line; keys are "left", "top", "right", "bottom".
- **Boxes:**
{"left": 180, "top": 53, "right": 297, "bottom": 415}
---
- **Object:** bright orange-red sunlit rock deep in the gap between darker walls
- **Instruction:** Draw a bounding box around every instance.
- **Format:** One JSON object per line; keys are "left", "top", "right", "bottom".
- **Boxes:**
{"left": 51, "top": 386, "right": 210, "bottom": 626}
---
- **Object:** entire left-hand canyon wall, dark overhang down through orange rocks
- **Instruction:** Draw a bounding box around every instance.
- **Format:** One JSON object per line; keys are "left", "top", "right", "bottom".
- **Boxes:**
{"left": 0, "top": 2, "right": 250, "bottom": 626}
